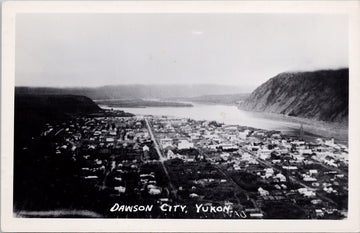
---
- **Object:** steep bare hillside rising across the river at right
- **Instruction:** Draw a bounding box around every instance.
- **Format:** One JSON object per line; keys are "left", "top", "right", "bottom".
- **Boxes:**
{"left": 239, "top": 69, "right": 349, "bottom": 123}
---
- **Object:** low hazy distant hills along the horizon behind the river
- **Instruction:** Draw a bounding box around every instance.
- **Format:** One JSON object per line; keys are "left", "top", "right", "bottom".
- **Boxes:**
{"left": 15, "top": 84, "right": 242, "bottom": 100}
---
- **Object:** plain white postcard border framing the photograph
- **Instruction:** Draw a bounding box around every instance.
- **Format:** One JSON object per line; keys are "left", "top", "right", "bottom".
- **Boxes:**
{"left": 1, "top": 1, "right": 360, "bottom": 232}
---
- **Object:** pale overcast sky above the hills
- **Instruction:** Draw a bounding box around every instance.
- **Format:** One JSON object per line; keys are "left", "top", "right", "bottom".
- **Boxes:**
{"left": 15, "top": 14, "right": 348, "bottom": 91}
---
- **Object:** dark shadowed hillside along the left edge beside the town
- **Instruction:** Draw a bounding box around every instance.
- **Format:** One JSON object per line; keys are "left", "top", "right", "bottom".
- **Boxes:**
{"left": 13, "top": 94, "right": 133, "bottom": 218}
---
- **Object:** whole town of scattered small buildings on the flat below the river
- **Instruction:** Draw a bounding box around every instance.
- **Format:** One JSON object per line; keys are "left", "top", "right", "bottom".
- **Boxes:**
{"left": 28, "top": 112, "right": 348, "bottom": 219}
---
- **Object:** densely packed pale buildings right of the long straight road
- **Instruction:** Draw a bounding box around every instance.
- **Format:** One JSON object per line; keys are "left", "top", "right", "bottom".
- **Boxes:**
{"left": 148, "top": 117, "right": 348, "bottom": 217}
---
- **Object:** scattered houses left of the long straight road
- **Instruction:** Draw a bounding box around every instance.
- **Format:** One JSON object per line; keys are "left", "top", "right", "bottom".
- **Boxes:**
{"left": 41, "top": 117, "right": 169, "bottom": 198}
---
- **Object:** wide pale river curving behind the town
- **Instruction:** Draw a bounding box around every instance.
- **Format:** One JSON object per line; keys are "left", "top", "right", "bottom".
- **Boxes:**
{"left": 100, "top": 103, "right": 347, "bottom": 142}
